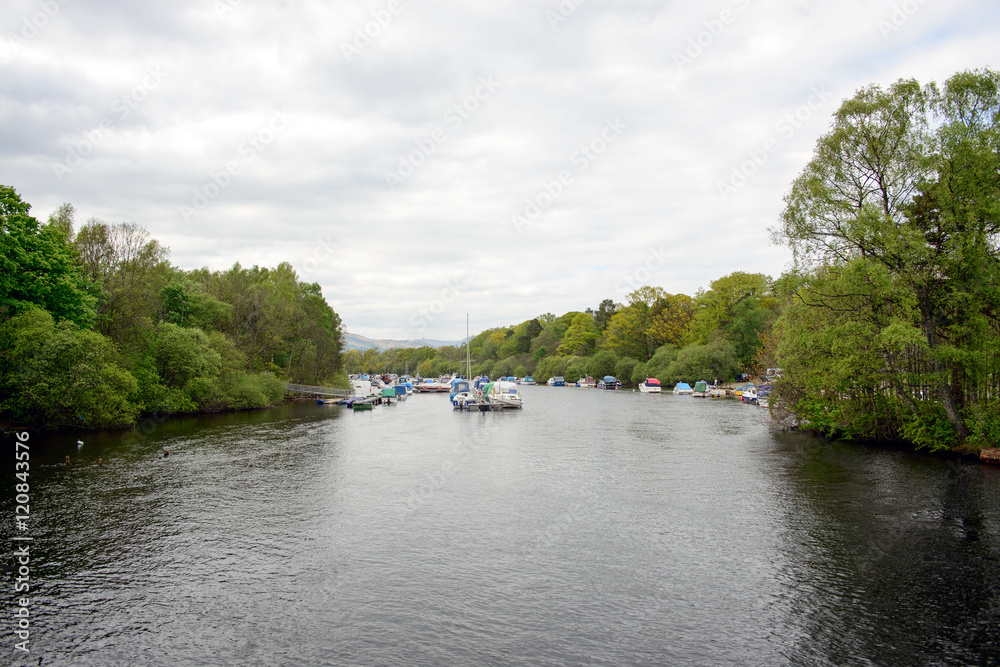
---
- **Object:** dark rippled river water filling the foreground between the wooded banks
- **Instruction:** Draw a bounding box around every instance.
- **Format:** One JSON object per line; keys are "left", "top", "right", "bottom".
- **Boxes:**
{"left": 2, "top": 387, "right": 1000, "bottom": 667}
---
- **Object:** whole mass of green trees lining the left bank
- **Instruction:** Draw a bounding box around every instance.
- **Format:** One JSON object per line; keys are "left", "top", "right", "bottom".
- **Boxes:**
{"left": 0, "top": 186, "right": 346, "bottom": 428}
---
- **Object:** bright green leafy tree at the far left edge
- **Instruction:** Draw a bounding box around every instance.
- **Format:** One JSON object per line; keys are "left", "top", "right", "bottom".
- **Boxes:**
{"left": 0, "top": 185, "right": 95, "bottom": 327}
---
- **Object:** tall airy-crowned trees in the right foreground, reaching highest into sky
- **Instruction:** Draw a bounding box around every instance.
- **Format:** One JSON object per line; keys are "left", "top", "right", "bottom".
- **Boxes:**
{"left": 775, "top": 70, "right": 1000, "bottom": 447}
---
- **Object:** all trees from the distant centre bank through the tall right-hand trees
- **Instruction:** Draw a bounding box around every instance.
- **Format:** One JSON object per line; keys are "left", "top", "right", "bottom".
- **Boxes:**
{"left": 345, "top": 70, "right": 1000, "bottom": 450}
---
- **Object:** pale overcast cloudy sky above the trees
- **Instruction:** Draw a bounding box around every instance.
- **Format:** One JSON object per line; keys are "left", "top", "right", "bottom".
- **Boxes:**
{"left": 0, "top": 0, "right": 1000, "bottom": 340}
